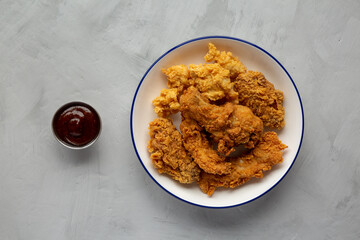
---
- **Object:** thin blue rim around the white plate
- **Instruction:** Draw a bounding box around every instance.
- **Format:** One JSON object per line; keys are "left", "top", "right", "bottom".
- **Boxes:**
{"left": 130, "top": 35, "right": 304, "bottom": 209}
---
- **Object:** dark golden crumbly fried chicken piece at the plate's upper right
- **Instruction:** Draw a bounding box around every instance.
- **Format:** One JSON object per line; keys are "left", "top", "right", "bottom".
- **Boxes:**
{"left": 235, "top": 71, "right": 285, "bottom": 129}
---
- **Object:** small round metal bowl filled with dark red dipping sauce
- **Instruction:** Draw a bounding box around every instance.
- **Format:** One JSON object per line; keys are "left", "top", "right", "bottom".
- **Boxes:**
{"left": 52, "top": 101, "right": 101, "bottom": 149}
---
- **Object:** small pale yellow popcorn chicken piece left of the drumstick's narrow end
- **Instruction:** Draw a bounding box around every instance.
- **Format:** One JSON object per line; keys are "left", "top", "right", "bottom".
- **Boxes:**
{"left": 152, "top": 88, "right": 180, "bottom": 117}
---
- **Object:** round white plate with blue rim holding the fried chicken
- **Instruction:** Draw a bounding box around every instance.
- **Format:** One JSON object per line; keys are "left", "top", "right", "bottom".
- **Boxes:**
{"left": 130, "top": 36, "right": 304, "bottom": 208}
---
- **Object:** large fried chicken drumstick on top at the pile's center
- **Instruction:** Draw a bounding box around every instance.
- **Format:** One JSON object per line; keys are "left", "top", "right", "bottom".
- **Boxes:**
{"left": 180, "top": 87, "right": 263, "bottom": 155}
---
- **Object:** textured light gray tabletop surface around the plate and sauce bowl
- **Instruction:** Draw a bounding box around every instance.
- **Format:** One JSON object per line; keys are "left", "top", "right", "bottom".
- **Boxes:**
{"left": 0, "top": 0, "right": 360, "bottom": 240}
